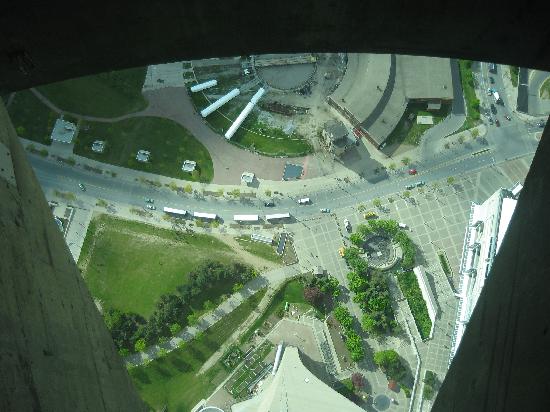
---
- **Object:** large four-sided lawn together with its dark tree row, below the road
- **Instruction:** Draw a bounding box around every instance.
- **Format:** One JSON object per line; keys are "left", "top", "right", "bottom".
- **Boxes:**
{"left": 79, "top": 215, "right": 262, "bottom": 355}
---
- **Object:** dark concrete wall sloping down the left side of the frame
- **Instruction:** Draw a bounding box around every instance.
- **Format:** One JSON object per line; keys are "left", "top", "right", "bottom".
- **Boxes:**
{"left": 0, "top": 101, "right": 145, "bottom": 411}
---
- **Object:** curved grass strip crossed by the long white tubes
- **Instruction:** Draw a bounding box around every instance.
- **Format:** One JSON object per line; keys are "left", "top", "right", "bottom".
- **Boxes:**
{"left": 191, "top": 88, "right": 313, "bottom": 156}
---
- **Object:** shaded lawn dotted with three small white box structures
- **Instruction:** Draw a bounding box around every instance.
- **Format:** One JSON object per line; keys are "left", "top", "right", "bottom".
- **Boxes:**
{"left": 74, "top": 117, "right": 214, "bottom": 183}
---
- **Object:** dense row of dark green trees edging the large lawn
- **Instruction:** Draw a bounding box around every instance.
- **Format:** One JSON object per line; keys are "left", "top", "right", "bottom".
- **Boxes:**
{"left": 104, "top": 261, "right": 257, "bottom": 355}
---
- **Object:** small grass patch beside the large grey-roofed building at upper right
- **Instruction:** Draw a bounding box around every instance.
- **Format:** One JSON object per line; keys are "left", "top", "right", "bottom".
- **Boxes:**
{"left": 386, "top": 103, "right": 450, "bottom": 146}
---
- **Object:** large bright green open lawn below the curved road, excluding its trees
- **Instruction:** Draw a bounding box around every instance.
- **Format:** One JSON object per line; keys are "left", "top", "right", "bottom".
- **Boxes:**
{"left": 78, "top": 215, "right": 236, "bottom": 318}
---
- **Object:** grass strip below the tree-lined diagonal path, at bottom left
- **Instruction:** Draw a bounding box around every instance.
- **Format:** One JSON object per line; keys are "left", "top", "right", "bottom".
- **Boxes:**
{"left": 130, "top": 289, "right": 265, "bottom": 412}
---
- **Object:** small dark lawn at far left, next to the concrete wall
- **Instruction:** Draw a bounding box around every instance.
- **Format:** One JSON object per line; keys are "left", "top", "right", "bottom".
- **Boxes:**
{"left": 8, "top": 90, "right": 59, "bottom": 145}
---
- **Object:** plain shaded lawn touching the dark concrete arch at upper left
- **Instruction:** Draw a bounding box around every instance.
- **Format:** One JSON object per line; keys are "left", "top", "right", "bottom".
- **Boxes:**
{"left": 38, "top": 67, "right": 148, "bottom": 117}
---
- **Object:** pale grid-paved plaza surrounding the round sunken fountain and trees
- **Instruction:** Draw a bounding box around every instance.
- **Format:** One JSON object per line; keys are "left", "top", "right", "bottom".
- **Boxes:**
{"left": 287, "top": 155, "right": 533, "bottom": 410}
